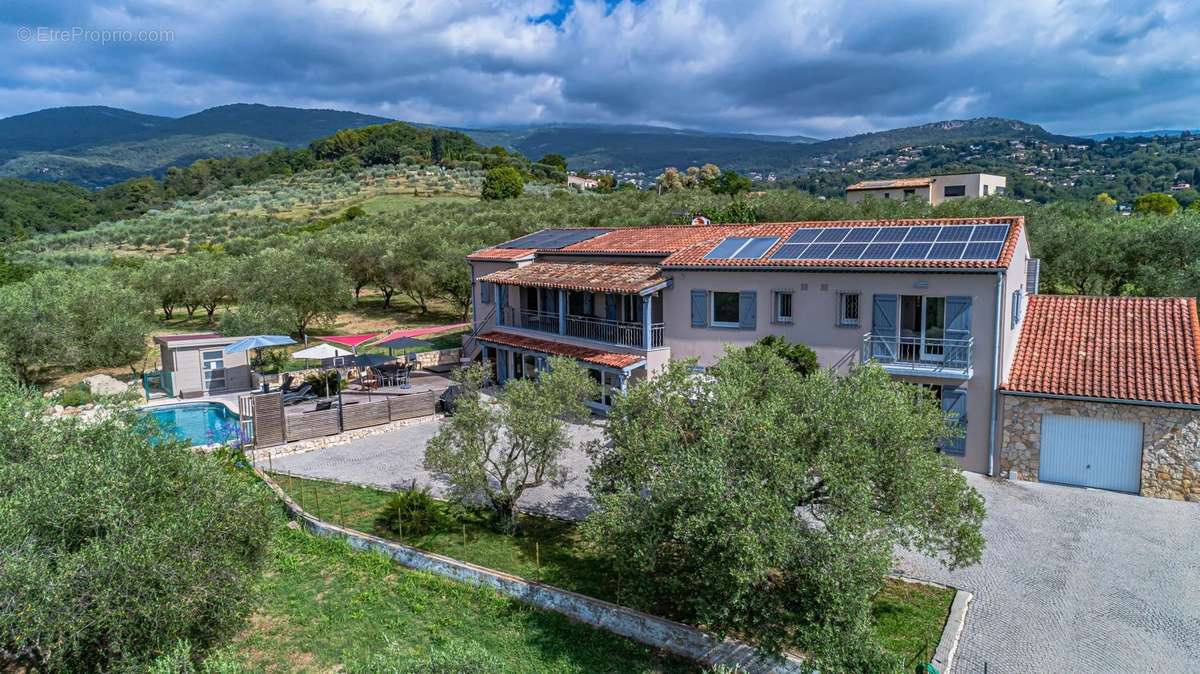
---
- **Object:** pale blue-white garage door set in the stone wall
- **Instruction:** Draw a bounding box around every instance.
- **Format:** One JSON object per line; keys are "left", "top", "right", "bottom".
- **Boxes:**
{"left": 1038, "top": 414, "right": 1141, "bottom": 494}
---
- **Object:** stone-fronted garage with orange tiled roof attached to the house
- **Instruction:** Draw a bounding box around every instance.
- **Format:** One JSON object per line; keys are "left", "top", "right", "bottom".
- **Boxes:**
{"left": 1001, "top": 295, "right": 1200, "bottom": 501}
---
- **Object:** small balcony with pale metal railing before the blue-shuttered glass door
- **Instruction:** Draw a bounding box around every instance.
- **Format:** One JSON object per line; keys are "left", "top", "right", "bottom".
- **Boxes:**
{"left": 859, "top": 332, "right": 974, "bottom": 380}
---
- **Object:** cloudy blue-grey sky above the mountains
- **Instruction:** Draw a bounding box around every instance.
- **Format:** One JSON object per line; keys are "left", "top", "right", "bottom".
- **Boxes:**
{"left": 0, "top": 0, "right": 1200, "bottom": 137}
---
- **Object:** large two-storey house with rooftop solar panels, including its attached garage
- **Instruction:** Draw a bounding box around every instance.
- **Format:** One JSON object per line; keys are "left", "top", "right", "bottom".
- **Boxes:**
{"left": 466, "top": 217, "right": 1200, "bottom": 500}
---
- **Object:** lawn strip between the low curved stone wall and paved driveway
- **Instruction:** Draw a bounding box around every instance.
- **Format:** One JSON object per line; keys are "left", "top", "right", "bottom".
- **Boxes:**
{"left": 267, "top": 475, "right": 954, "bottom": 661}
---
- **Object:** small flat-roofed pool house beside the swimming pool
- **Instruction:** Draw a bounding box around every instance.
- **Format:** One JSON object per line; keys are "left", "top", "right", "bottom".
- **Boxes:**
{"left": 154, "top": 332, "right": 253, "bottom": 398}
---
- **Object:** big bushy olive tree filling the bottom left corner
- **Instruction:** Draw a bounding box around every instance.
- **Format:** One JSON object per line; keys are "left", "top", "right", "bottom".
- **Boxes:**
{"left": 0, "top": 374, "right": 275, "bottom": 672}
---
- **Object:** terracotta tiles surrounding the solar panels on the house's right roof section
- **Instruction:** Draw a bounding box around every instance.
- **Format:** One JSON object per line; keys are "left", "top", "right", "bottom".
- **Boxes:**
{"left": 662, "top": 216, "right": 1025, "bottom": 270}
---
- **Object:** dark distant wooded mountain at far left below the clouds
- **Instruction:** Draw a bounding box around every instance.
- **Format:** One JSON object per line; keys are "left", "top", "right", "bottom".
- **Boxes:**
{"left": 0, "top": 103, "right": 391, "bottom": 189}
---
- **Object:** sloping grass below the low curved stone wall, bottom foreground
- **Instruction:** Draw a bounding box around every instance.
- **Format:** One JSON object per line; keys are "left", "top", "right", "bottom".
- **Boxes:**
{"left": 230, "top": 526, "right": 697, "bottom": 674}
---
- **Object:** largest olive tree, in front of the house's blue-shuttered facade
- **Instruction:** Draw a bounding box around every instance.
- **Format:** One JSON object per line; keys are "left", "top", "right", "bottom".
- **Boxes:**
{"left": 584, "top": 348, "right": 984, "bottom": 672}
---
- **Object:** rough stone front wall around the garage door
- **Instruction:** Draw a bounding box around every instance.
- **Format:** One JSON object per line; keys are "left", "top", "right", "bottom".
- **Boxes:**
{"left": 1000, "top": 395, "right": 1200, "bottom": 501}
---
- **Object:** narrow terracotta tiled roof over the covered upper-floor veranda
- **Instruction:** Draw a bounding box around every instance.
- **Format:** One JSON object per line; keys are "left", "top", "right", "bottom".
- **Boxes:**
{"left": 480, "top": 263, "right": 662, "bottom": 294}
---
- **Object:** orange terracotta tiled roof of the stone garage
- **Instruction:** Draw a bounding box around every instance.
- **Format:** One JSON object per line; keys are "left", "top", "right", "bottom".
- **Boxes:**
{"left": 1003, "top": 295, "right": 1200, "bottom": 405}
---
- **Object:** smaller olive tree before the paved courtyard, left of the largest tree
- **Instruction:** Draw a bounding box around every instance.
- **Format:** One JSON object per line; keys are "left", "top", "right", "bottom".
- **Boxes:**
{"left": 425, "top": 357, "right": 596, "bottom": 529}
